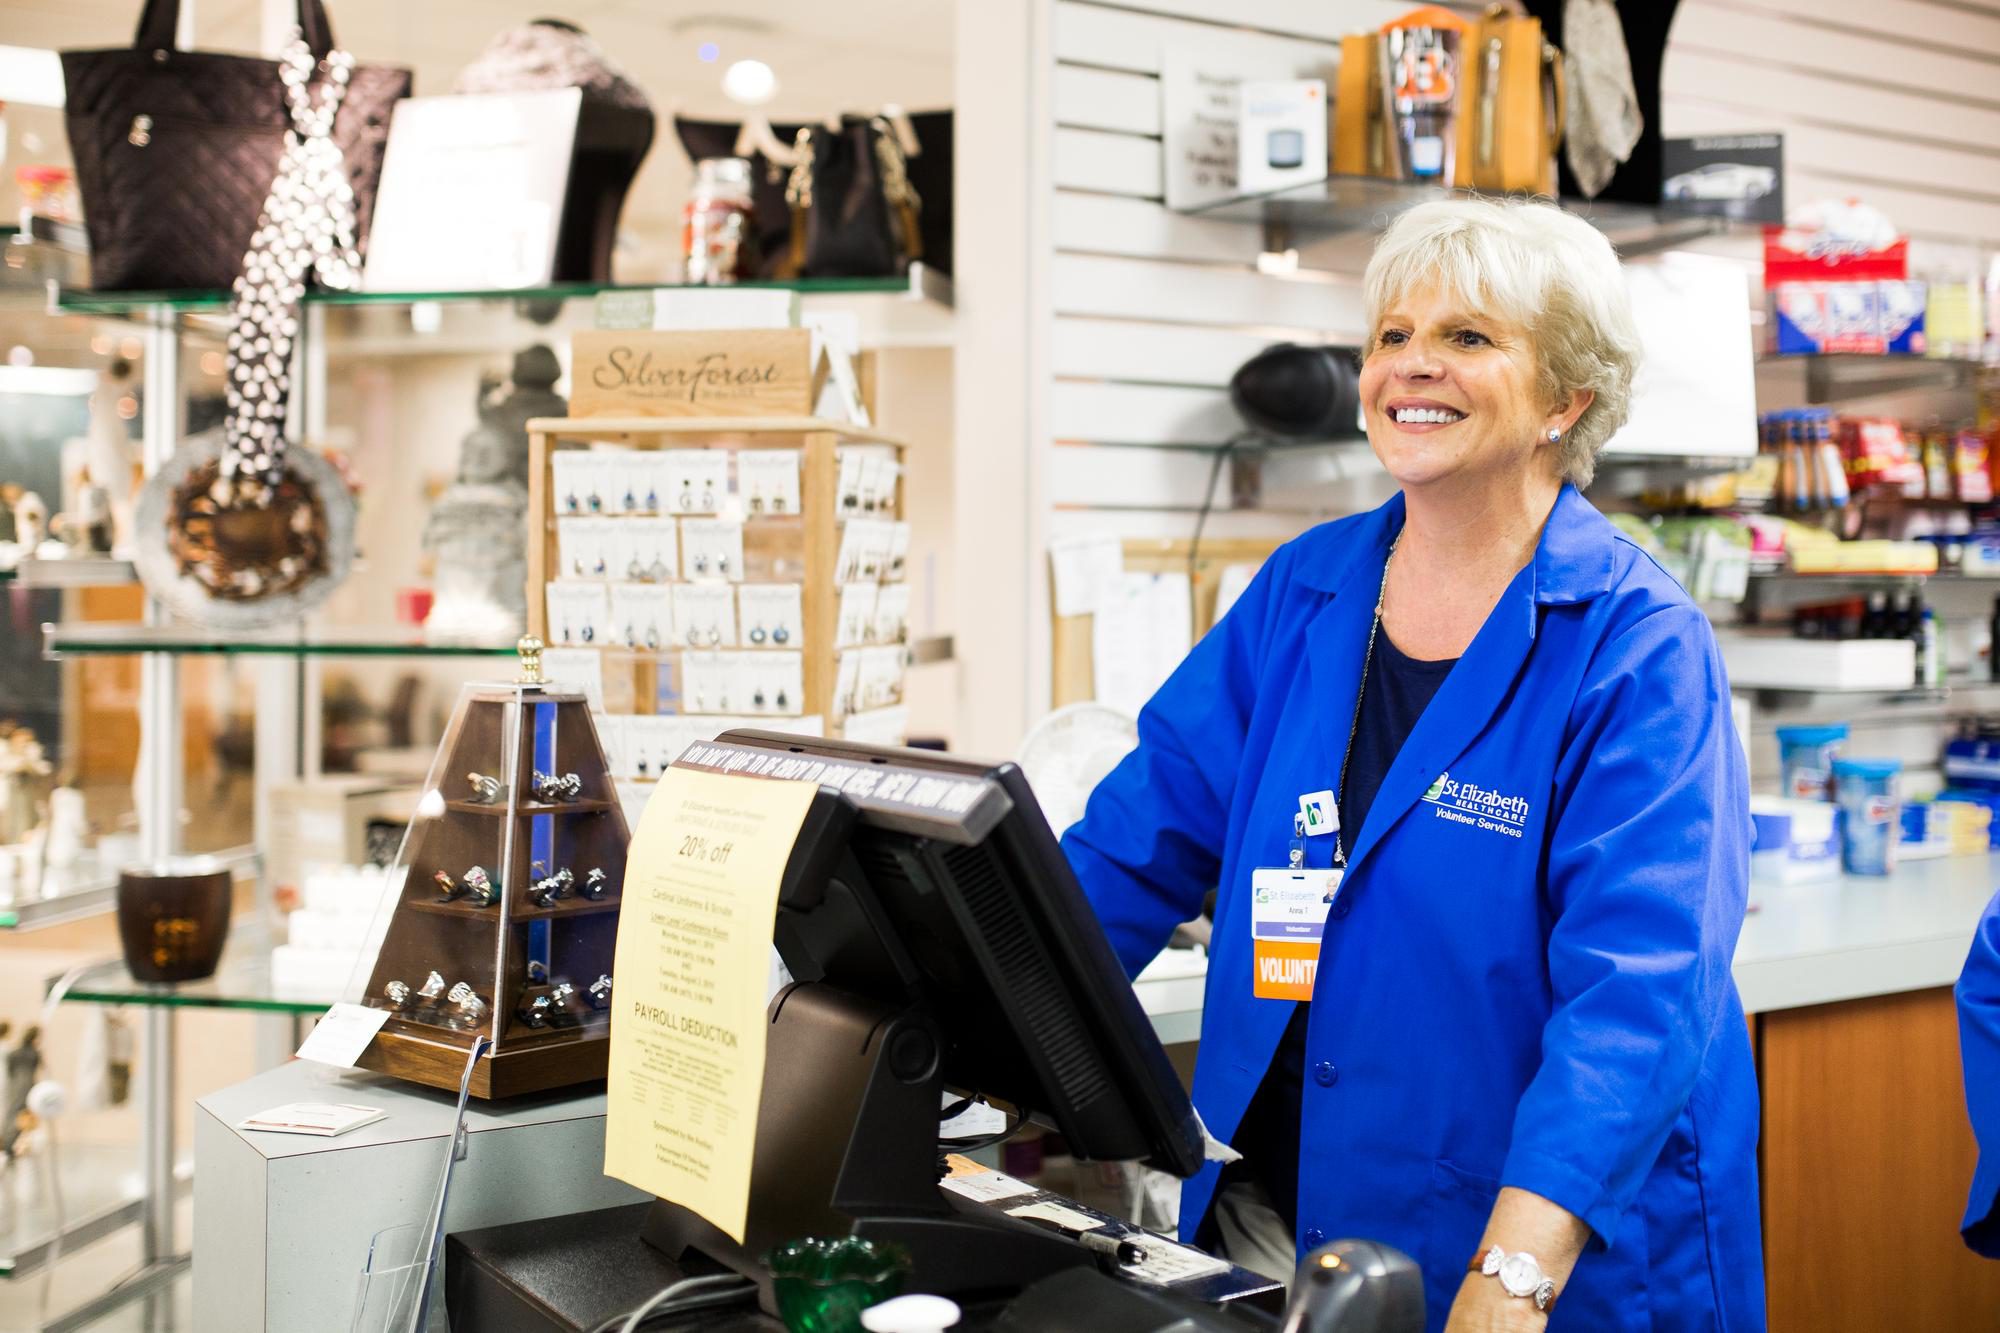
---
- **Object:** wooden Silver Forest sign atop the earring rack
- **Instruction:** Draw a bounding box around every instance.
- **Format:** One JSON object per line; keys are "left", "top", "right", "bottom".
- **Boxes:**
{"left": 570, "top": 328, "right": 818, "bottom": 416}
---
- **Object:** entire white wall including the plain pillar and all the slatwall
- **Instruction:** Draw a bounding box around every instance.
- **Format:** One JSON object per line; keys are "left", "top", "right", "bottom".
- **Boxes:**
{"left": 958, "top": 0, "right": 2000, "bottom": 751}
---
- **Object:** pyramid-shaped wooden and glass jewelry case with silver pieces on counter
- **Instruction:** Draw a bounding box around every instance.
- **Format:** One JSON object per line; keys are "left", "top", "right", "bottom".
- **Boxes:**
{"left": 360, "top": 636, "right": 630, "bottom": 1099}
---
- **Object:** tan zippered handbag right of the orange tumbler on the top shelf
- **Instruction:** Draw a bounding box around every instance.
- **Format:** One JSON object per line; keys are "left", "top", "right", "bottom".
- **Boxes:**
{"left": 1452, "top": 4, "right": 1568, "bottom": 194}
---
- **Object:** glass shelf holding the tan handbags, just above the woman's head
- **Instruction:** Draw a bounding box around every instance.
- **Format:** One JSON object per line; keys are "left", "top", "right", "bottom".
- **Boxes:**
{"left": 1186, "top": 176, "right": 1742, "bottom": 258}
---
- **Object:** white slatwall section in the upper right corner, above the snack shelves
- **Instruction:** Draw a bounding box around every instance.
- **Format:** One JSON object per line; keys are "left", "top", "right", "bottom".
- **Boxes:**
{"left": 1660, "top": 0, "right": 2000, "bottom": 246}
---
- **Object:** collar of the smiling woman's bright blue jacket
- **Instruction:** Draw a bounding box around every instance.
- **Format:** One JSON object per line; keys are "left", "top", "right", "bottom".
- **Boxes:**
{"left": 1292, "top": 482, "right": 1618, "bottom": 606}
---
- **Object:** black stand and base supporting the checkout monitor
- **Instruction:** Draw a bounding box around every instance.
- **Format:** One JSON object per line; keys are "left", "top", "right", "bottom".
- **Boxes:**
{"left": 642, "top": 983, "right": 1094, "bottom": 1307}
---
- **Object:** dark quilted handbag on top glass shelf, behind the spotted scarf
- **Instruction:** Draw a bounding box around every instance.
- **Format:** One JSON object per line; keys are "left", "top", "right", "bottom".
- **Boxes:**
{"left": 62, "top": 0, "right": 410, "bottom": 292}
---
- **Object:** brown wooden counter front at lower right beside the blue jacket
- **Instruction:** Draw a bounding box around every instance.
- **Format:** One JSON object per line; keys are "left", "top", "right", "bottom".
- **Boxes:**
{"left": 1754, "top": 987, "right": 2000, "bottom": 1333}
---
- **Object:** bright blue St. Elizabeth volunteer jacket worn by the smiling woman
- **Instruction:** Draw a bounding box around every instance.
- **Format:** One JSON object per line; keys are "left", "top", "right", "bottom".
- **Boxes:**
{"left": 1064, "top": 486, "right": 1764, "bottom": 1333}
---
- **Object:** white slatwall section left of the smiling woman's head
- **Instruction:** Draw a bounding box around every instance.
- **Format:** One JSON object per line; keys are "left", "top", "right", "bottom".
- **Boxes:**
{"left": 1048, "top": 0, "right": 1478, "bottom": 536}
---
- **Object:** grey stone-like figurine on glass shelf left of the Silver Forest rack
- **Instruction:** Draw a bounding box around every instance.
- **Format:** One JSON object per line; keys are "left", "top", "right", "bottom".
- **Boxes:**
{"left": 424, "top": 344, "right": 568, "bottom": 640}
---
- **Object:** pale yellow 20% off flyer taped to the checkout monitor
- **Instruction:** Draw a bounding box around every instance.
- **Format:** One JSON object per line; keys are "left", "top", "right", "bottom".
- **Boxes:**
{"left": 604, "top": 769, "right": 816, "bottom": 1241}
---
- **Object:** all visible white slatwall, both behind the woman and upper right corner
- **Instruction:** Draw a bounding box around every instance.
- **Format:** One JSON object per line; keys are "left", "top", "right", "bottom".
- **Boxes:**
{"left": 1050, "top": 0, "right": 2000, "bottom": 534}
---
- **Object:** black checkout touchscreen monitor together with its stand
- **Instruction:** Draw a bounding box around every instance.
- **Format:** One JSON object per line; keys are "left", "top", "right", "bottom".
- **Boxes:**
{"left": 646, "top": 731, "right": 1204, "bottom": 1291}
